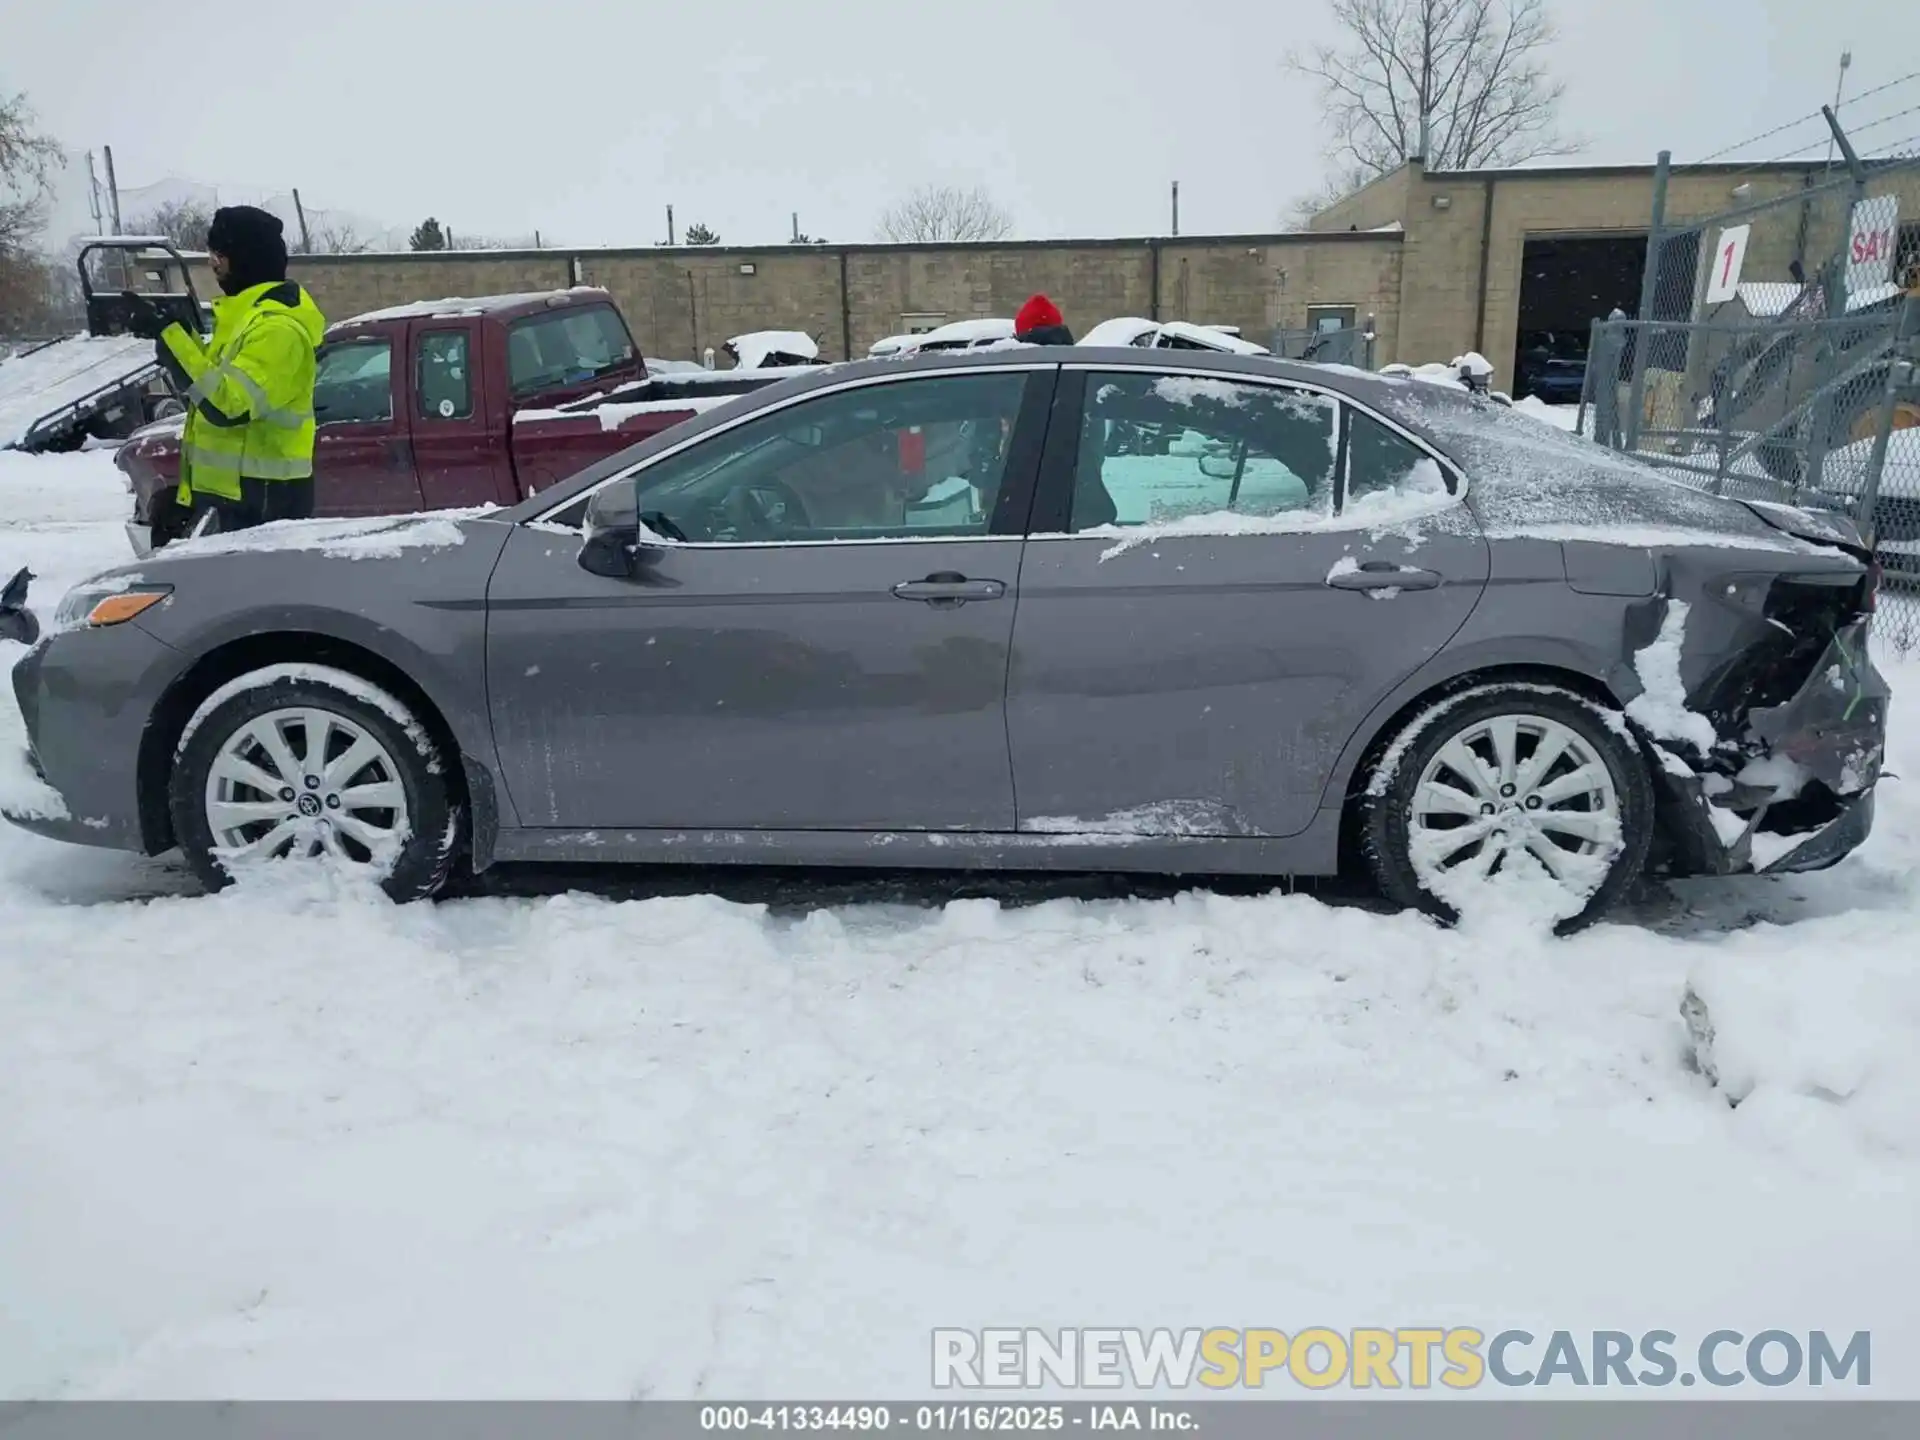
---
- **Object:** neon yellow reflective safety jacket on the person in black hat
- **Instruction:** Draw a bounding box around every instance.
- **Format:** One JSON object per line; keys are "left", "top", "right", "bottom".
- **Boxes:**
{"left": 156, "top": 280, "right": 326, "bottom": 507}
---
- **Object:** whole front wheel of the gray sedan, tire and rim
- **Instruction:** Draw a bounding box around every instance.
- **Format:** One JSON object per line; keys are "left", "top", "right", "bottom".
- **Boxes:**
{"left": 169, "top": 664, "right": 465, "bottom": 900}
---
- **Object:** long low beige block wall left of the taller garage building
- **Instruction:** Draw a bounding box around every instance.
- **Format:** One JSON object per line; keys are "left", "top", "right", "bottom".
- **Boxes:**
{"left": 278, "top": 234, "right": 1400, "bottom": 359}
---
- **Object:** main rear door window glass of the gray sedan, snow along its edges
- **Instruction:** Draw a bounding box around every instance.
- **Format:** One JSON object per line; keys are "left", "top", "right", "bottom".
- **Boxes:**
{"left": 1068, "top": 372, "right": 1338, "bottom": 532}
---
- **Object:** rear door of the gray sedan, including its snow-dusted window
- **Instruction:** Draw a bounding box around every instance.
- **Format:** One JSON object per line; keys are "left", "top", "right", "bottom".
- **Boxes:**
{"left": 1008, "top": 369, "right": 1488, "bottom": 835}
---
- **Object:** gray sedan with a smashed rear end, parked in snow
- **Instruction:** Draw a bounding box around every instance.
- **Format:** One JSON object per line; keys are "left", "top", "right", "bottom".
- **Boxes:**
{"left": 0, "top": 348, "right": 1887, "bottom": 927}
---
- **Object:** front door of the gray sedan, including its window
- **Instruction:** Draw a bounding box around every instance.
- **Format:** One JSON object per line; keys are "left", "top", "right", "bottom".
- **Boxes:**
{"left": 488, "top": 367, "right": 1056, "bottom": 831}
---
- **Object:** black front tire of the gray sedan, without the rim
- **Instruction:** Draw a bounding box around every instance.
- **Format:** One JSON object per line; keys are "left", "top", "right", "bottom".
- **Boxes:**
{"left": 167, "top": 664, "right": 467, "bottom": 902}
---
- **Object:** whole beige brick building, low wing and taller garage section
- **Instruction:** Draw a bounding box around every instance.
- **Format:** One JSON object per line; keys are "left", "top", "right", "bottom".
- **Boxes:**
{"left": 176, "top": 161, "right": 1920, "bottom": 388}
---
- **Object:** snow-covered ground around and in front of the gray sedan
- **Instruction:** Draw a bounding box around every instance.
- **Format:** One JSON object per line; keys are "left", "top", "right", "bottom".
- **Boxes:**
{"left": 0, "top": 455, "right": 1920, "bottom": 1400}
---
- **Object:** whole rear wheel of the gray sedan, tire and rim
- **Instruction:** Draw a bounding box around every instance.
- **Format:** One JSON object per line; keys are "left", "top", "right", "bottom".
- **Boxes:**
{"left": 1363, "top": 682, "right": 1653, "bottom": 935}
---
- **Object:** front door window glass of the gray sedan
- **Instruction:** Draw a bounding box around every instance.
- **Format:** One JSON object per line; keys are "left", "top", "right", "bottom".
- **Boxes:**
{"left": 636, "top": 372, "right": 1025, "bottom": 543}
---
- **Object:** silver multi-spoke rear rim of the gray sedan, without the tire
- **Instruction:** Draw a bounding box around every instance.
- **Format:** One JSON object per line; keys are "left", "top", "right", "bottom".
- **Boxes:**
{"left": 1407, "top": 714, "right": 1622, "bottom": 897}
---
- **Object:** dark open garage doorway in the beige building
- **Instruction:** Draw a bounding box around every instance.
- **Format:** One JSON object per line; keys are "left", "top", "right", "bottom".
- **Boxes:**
{"left": 1513, "top": 234, "right": 1647, "bottom": 405}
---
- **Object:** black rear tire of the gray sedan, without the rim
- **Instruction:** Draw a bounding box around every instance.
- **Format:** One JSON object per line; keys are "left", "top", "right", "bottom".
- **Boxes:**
{"left": 1359, "top": 682, "right": 1655, "bottom": 935}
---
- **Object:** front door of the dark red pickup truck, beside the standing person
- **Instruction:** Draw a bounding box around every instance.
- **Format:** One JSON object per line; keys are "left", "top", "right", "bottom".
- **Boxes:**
{"left": 313, "top": 338, "right": 420, "bottom": 515}
